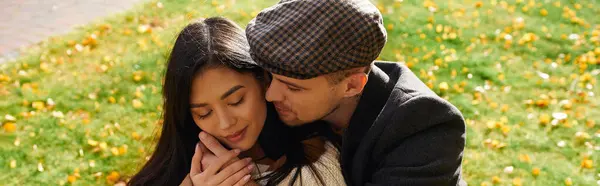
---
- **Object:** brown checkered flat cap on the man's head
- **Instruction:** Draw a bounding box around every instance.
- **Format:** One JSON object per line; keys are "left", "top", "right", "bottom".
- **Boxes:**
{"left": 246, "top": 0, "right": 387, "bottom": 79}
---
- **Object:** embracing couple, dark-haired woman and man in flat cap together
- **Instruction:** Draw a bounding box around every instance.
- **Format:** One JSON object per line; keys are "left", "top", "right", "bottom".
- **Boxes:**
{"left": 129, "top": 0, "right": 465, "bottom": 186}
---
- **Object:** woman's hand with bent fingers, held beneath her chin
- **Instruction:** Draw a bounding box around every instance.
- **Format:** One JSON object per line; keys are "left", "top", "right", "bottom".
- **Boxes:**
{"left": 184, "top": 144, "right": 254, "bottom": 186}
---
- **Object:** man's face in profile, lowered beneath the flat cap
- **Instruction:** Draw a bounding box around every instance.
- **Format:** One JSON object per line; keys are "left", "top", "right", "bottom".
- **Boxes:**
{"left": 266, "top": 74, "right": 343, "bottom": 126}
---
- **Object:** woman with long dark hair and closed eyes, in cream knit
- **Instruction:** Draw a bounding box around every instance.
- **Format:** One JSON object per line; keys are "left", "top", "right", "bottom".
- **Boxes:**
{"left": 129, "top": 18, "right": 344, "bottom": 185}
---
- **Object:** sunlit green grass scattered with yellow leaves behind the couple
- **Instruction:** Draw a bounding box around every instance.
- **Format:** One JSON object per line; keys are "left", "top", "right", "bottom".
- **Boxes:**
{"left": 0, "top": 0, "right": 600, "bottom": 185}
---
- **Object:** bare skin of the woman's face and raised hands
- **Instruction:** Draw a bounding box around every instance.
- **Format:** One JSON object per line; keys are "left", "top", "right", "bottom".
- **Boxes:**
{"left": 181, "top": 67, "right": 267, "bottom": 185}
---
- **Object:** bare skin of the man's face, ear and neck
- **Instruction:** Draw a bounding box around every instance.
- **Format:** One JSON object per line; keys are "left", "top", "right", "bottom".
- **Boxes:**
{"left": 266, "top": 67, "right": 367, "bottom": 128}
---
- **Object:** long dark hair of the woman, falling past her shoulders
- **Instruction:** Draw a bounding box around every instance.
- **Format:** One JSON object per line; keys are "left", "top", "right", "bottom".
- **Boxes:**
{"left": 128, "top": 17, "right": 338, "bottom": 185}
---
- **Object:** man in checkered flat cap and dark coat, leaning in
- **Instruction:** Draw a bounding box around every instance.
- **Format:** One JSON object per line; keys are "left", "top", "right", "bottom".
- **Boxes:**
{"left": 246, "top": 0, "right": 465, "bottom": 185}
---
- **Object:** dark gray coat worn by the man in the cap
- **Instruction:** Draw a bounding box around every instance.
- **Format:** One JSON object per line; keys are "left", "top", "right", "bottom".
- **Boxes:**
{"left": 341, "top": 62, "right": 466, "bottom": 185}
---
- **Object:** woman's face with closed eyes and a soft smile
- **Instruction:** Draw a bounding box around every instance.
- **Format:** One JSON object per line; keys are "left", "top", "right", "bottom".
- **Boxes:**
{"left": 190, "top": 67, "right": 267, "bottom": 151}
